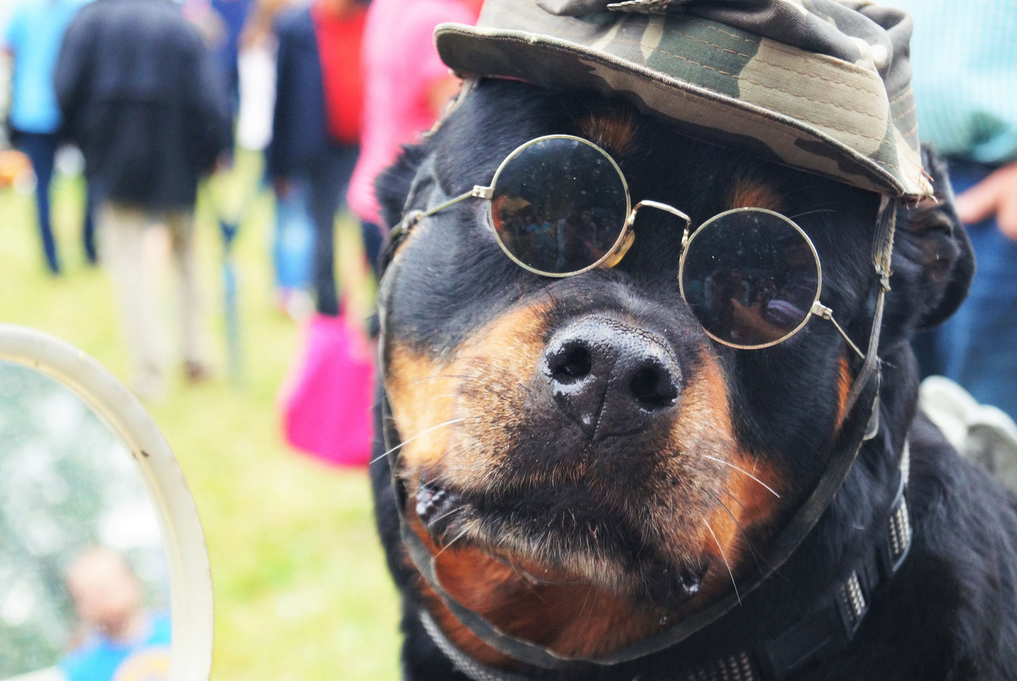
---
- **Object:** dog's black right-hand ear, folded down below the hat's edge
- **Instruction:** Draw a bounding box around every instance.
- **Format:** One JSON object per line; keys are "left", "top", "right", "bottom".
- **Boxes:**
{"left": 900, "top": 145, "right": 974, "bottom": 329}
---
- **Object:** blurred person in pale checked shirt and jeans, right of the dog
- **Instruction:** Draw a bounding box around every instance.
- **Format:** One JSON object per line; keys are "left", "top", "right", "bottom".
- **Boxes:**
{"left": 894, "top": 0, "right": 1017, "bottom": 419}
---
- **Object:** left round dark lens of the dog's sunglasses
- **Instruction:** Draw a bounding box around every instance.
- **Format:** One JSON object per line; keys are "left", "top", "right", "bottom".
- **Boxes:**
{"left": 491, "top": 137, "right": 627, "bottom": 274}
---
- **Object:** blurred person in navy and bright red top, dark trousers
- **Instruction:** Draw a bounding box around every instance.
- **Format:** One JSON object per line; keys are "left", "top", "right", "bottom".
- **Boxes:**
{"left": 266, "top": 0, "right": 366, "bottom": 316}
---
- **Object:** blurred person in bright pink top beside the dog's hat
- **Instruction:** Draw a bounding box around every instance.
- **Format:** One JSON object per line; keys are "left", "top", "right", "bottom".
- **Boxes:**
{"left": 347, "top": 0, "right": 482, "bottom": 274}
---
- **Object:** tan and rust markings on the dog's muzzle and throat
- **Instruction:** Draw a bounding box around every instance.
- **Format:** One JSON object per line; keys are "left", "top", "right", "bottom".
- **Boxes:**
{"left": 385, "top": 321, "right": 781, "bottom": 669}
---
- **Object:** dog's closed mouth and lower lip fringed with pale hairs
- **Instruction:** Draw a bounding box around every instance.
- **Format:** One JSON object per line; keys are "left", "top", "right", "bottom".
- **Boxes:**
{"left": 415, "top": 479, "right": 710, "bottom": 620}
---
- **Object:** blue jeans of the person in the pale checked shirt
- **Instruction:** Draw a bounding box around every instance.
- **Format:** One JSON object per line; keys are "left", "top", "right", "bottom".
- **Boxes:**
{"left": 913, "top": 161, "right": 1017, "bottom": 420}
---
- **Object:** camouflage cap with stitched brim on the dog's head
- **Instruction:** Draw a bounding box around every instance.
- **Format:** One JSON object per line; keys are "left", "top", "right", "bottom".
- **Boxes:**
{"left": 435, "top": 0, "right": 932, "bottom": 199}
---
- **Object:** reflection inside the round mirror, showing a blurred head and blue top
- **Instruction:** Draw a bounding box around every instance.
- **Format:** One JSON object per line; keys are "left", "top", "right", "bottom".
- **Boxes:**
{"left": 0, "top": 361, "right": 170, "bottom": 681}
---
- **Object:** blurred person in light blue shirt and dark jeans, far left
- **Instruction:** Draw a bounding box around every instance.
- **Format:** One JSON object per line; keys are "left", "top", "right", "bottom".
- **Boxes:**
{"left": 3, "top": 0, "right": 96, "bottom": 274}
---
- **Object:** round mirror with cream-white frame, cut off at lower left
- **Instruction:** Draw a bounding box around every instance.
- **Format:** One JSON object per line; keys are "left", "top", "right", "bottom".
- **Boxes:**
{"left": 0, "top": 324, "right": 213, "bottom": 681}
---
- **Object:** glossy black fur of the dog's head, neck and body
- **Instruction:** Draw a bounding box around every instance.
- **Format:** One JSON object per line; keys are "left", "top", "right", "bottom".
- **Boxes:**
{"left": 372, "top": 81, "right": 1017, "bottom": 681}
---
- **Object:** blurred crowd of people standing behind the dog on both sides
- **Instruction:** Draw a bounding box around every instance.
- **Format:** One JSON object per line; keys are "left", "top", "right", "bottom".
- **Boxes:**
{"left": 0, "top": 0, "right": 1017, "bottom": 417}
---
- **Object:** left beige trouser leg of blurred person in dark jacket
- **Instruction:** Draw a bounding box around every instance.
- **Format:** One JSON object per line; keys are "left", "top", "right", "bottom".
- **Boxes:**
{"left": 96, "top": 201, "right": 165, "bottom": 398}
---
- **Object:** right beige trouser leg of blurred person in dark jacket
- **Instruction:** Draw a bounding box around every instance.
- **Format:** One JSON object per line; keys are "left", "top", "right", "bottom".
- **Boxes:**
{"left": 166, "top": 209, "right": 208, "bottom": 380}
